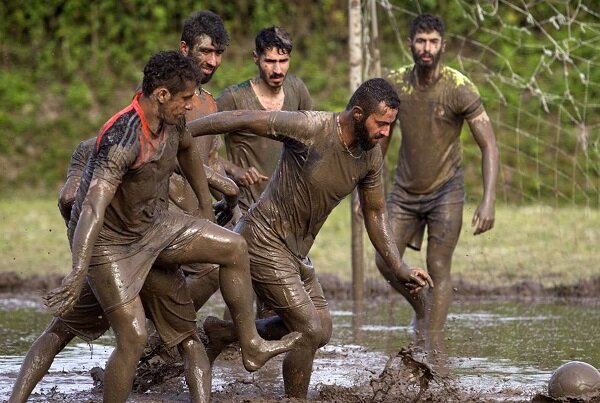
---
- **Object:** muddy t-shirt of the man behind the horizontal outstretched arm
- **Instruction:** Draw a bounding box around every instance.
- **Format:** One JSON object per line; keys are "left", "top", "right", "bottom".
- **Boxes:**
{"left": 217, "top": 75, "right": 312, "bottom": 210}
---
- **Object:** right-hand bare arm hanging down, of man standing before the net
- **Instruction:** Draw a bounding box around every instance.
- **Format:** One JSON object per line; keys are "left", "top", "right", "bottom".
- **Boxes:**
{"left": 467, "top": 111, "right": 498, "bottom": 235}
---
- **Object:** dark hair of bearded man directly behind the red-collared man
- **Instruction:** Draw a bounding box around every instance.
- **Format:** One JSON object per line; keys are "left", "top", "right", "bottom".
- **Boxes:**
{"left": 181, "top": 10, "right": 229, "bottom": 49}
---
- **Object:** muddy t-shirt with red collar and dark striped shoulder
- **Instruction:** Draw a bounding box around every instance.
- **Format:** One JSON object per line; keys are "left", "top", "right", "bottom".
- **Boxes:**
{"left": 69, "top": 95, "right": 182, "bottom": 245}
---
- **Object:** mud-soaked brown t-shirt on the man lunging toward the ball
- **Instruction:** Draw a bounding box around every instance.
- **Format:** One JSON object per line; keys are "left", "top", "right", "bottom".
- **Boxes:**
{"left": 242, "top": 111, "right": 383, "bottom": 258}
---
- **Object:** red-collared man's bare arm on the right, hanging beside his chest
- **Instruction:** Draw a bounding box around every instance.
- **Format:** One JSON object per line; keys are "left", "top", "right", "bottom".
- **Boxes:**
{"left": 177, "top": 131, "right": 214, "bottom": 221}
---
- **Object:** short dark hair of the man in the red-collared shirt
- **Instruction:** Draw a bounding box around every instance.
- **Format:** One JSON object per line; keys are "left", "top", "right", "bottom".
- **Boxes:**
{"left": 142, "top": 50, "right": 202, "bottom": 96}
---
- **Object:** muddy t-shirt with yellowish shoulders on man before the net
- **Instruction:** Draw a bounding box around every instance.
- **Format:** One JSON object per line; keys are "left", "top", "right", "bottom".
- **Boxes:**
{"left": 388, "top": 65, "right": 484, "bottom": 194}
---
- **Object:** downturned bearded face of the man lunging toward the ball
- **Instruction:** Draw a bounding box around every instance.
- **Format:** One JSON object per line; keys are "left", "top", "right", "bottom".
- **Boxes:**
{"left": 354, "top": 102, "right": 398, "bottom": 151}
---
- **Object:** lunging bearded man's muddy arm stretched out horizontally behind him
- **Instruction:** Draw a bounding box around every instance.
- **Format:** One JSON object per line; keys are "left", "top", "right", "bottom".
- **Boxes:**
{"left": 188, "top": 110, "right": 316, "bottom": 143}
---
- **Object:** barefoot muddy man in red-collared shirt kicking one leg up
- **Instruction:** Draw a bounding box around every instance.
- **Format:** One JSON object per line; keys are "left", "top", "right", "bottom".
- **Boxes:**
{"left": 11, "top": 52, "right": 298, "bottom": 402}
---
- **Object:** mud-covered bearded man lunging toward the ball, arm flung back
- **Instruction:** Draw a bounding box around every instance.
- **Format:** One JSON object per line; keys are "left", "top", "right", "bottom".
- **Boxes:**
{"left": 188, "top": 78, "right": 433, "bottom": 399}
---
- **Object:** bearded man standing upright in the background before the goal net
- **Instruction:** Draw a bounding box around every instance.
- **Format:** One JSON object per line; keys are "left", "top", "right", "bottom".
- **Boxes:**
{"left": 376, "top": 14, "right": 498, "bottom": 351}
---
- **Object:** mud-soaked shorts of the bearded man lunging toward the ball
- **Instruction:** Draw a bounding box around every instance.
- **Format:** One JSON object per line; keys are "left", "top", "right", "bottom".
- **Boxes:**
{"left": 236, "top": 221, "right": 328, "bottom": 310}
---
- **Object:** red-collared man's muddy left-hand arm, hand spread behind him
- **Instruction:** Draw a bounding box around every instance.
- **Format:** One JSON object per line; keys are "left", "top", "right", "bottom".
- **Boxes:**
{"left": 46, "top": 178, "right": 117, "bottom": 316}
